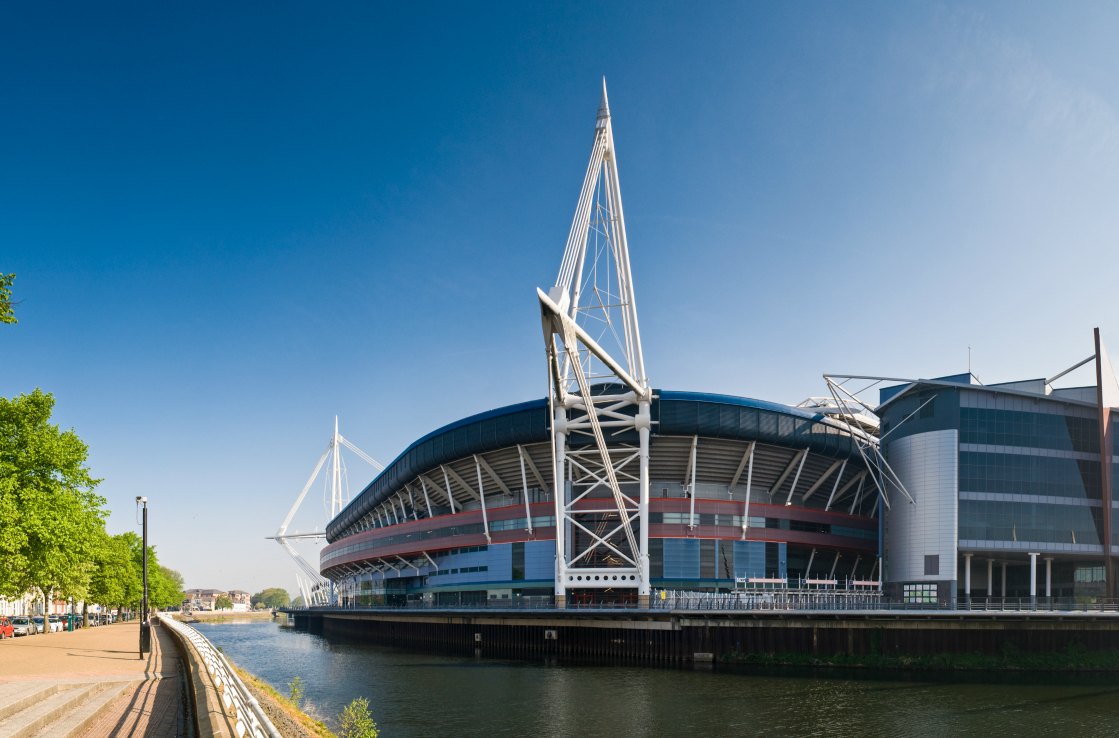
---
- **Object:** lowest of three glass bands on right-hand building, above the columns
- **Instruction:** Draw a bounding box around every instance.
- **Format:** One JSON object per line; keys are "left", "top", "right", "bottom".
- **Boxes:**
{"left": 959, "top": 500, "right": 1101, "bottom": 546}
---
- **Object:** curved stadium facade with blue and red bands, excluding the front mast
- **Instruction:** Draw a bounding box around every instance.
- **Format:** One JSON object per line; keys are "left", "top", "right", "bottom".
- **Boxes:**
{"left": 320, "top": 390, "right": 880, "bottom": 605}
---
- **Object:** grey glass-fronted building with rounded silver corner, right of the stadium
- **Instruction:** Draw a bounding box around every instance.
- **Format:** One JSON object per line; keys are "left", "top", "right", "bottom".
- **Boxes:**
{"left": 875, "top": 331, "right": 1119, "bottom": 603}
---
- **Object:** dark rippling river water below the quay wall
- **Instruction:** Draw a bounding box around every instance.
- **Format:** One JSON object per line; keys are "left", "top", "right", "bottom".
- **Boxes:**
{"left": 195, "top": 622, "right": 1119, "bottom": 738}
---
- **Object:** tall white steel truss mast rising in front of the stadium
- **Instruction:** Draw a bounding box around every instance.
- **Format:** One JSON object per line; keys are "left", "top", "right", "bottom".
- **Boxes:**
{"left": 537, "top": 79, "right": 652, "bottom": 607}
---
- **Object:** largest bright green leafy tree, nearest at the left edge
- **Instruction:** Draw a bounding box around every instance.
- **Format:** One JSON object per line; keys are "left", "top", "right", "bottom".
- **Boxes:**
{"left": 0, "top": 389, "right": 107, "bottom": 630}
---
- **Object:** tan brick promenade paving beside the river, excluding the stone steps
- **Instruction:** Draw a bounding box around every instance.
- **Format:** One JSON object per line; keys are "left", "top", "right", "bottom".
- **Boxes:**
{"left": 0, "top": 623, "right": 188, "bottom": 738}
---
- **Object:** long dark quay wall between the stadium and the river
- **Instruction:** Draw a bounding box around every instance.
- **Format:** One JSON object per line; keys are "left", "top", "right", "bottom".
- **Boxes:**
{"left": 290, "top": 609, "right": 1119, "bottom": 668}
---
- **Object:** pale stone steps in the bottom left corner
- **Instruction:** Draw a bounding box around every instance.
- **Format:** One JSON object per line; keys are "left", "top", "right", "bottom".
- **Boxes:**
{"left": 0, "top": 680, "right": 138, "bottom": 738}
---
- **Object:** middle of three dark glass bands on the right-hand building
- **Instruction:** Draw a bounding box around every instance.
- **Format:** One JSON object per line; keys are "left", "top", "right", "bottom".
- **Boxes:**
{"left": 960, "top": 451, "right": 1100, "bottom": 500}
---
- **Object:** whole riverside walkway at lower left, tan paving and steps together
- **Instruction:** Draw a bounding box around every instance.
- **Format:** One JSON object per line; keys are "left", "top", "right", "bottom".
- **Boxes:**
{"left": 0, "top": 622, "right": 189, "bottom": 738}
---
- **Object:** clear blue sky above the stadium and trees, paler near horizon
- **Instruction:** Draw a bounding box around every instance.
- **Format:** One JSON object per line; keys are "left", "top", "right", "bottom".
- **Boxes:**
{"left": 0, "top": 1, "right": 1119, "bottom": 592}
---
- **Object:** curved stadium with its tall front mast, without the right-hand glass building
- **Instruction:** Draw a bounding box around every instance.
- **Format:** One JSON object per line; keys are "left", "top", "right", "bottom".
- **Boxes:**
{"left": 319, "top": 86, "right": 885, "bottom": 607}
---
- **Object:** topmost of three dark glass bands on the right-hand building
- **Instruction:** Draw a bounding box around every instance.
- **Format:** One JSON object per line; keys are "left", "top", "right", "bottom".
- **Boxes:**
{"left": 960, "top": 407, "right": 1100, "bottom": 454}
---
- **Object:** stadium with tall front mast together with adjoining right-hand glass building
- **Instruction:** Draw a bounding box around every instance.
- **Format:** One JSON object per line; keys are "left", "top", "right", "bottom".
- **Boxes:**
{"left": 313, "top": 88, "right": 1119, "bottom": 608}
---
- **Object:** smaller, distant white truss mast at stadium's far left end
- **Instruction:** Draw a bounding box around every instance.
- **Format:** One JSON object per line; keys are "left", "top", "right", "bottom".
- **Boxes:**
{"left": 270, "top": 415, "right": 385, "bottom": 606}
